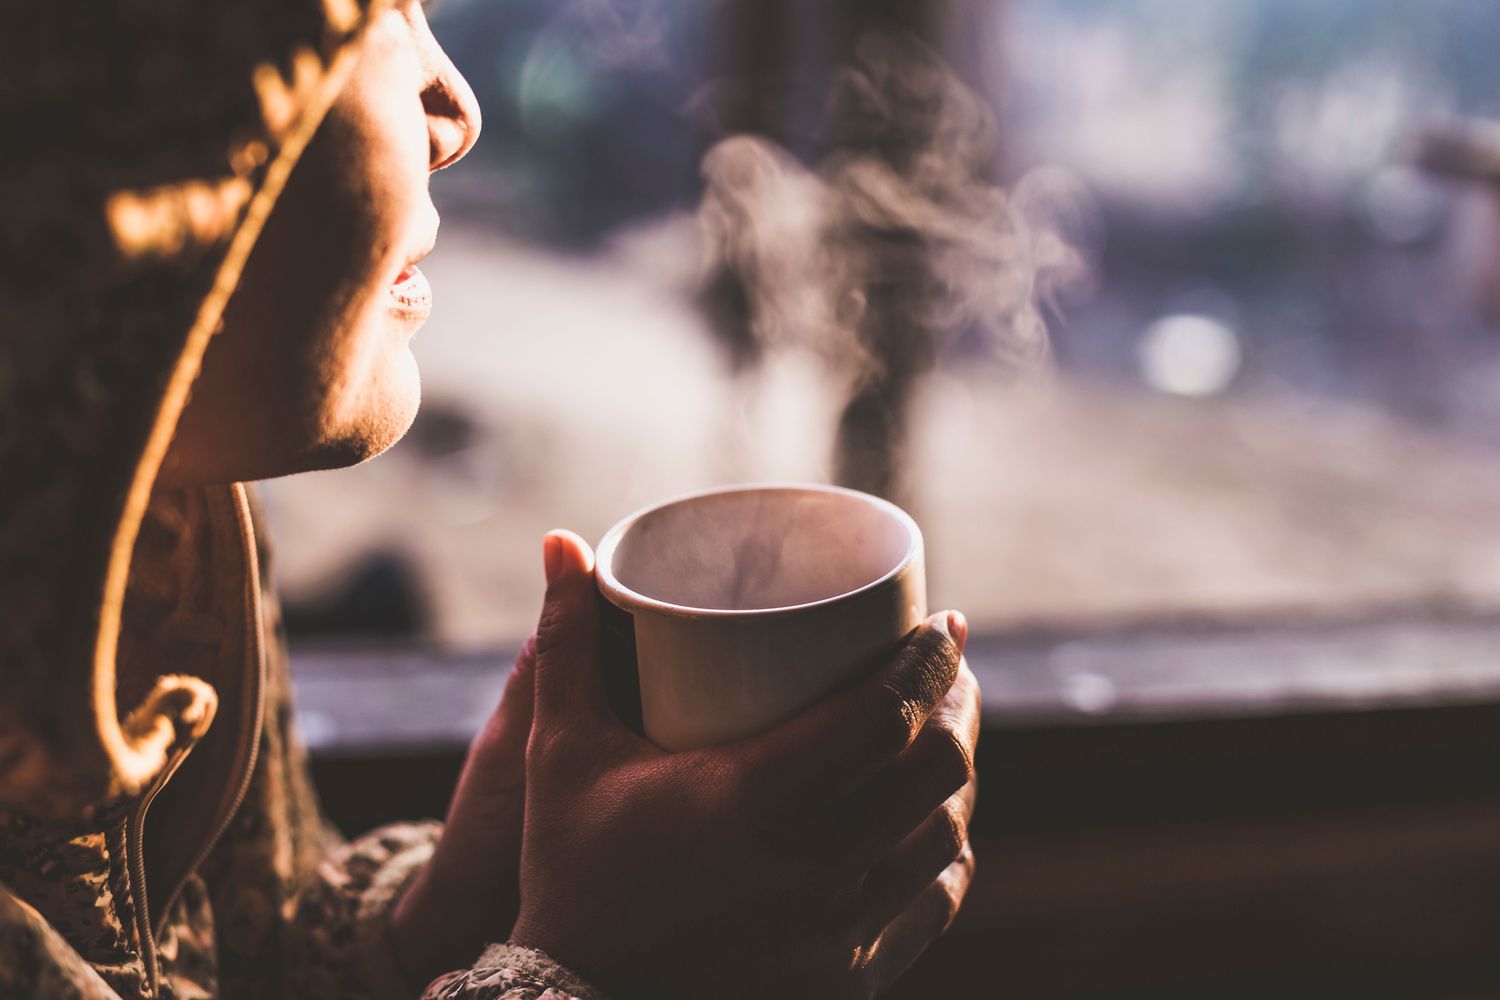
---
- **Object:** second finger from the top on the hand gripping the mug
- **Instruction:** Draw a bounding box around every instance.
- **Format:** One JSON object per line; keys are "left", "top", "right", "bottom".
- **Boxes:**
{"left": 833, "top": 666, "right": 980, "bottom": 870}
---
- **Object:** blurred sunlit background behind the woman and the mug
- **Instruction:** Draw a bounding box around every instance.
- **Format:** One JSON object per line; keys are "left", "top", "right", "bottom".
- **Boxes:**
{"left": 276, "top": 0, "right": 1500, "bottom": 997}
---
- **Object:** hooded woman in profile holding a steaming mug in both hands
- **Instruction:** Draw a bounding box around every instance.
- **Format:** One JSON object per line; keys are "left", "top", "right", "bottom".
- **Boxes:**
{"left": 0, "top": 0, "right": 978, "bottom": 1000}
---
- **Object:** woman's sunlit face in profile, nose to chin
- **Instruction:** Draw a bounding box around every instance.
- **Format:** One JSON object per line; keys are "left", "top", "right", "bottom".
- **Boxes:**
{"left": 161, "top": 0, "right": 480, "bottom": 484}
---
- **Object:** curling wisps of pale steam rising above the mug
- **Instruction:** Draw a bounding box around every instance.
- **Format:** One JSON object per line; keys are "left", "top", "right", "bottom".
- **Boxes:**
{"left": 698, "top": 33, "right": 1098, "bottom": 378}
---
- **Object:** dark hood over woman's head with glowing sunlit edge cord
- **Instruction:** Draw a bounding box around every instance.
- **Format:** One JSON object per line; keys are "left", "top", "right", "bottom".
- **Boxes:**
{"left": 0, "top": 0, "right": 389, "bottom": 816}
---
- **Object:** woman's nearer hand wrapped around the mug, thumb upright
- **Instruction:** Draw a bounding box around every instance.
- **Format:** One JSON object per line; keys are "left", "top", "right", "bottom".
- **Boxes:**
{"left": 512, "top": 532, "right": 980, "bottom": 999}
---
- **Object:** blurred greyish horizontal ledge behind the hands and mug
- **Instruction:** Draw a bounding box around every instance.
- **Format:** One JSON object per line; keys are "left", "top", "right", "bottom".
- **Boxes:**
{"left": 293, "top": 612, "right": 1500, "bottom": 753}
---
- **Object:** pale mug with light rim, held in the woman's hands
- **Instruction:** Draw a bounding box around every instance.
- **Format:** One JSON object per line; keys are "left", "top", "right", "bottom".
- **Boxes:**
{"left": 596, "top": 484, "right": 927, "bottom": 750}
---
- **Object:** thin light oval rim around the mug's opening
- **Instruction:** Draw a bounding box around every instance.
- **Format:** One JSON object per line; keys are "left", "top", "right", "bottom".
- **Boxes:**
{"left": 594, "top": 481, "right": 923, "bottom": 618}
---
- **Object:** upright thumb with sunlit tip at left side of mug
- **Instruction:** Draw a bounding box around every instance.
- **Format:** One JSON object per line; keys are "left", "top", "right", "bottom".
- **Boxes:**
{"left": 534, "top": 531, "right": 609, "bottom": 720}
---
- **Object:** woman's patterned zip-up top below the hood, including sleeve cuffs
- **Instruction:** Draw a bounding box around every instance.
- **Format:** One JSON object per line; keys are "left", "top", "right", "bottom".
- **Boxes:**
{"left": 0, "top": 487, "right": 600, "bottom": 1000}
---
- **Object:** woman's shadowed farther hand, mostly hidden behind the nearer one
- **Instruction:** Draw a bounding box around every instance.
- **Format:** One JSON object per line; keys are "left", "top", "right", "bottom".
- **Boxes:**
{"left": 392, "top": 640, "right": 536, "bottom": 991}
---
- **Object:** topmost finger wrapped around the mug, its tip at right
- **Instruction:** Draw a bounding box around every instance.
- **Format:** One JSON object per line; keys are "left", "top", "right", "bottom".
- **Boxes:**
{"left": 735, "top": 612, "right": 966, "bottom": 805}
